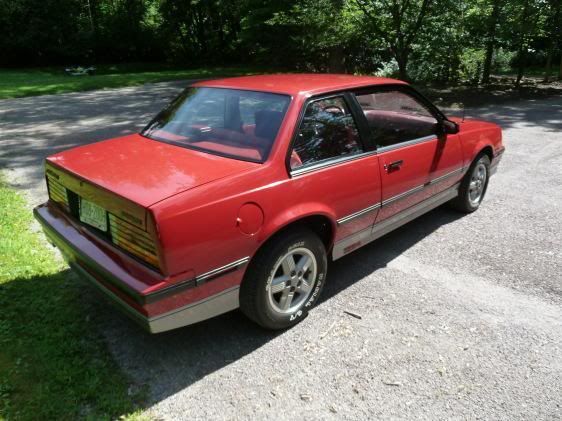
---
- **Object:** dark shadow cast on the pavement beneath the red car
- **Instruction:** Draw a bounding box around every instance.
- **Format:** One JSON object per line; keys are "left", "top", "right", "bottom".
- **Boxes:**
{"left": 83, "top": 208, "right": 461, "bottom": 406}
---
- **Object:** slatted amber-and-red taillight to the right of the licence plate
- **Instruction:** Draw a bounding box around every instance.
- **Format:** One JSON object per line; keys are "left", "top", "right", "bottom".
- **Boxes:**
{"left": 109, "top": 213, "right": 160, "bottom": 268}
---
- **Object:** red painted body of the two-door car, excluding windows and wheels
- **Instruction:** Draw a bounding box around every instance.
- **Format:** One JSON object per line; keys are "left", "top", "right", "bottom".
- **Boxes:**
{"left": 34, "top": 75, "right": 503, "bottom": 332}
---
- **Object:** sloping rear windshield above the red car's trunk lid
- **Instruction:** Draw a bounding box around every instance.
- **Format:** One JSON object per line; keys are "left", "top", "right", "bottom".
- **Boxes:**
{"left": 141, "top": 88, "right": 291, "bottom": 162}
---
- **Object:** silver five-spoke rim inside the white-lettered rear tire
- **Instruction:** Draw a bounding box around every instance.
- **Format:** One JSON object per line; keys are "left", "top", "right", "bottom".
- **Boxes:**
{"left": 268, "top": 248, "right": 318, "bottom": 314}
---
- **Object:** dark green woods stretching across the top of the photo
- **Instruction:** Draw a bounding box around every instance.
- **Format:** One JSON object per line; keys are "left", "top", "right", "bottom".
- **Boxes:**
{"left": 0, "top": 0, "right": 562, "bottom": 84}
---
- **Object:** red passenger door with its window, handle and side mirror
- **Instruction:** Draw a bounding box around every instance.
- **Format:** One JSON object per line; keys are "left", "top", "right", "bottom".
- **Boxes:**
{"left": 356, "top": 87, "right": 461, "bottom": 223}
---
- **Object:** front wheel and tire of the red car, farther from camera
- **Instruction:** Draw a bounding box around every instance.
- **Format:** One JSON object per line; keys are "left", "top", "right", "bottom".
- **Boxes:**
{"left": 450, "top": 154, "right": 490, "bottom": 213}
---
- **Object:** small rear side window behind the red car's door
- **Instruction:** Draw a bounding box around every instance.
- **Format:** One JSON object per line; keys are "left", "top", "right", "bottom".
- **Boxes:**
{"left": 291, "top": 97, "right": 363, "bottom": 169}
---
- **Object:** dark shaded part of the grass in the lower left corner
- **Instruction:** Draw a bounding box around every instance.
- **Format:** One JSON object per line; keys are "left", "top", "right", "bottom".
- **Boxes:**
{"left": 0, "top": 270, "right": 139, "bottom": 420}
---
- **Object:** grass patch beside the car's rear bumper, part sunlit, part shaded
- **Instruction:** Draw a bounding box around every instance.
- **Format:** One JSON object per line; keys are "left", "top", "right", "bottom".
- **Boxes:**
{"left": 0, "top": 178, "right": 144, "bottom": 420}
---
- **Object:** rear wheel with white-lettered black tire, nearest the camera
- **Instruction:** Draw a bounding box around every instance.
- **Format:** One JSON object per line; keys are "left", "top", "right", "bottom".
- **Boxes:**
{"left": 240, "top": 228, "right": 328, "bottom": 330}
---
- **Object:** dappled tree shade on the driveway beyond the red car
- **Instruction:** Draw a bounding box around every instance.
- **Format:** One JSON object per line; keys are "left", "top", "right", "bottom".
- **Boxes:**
{"left": 0, "top": 81, "right": 562, "bottom": 202}
